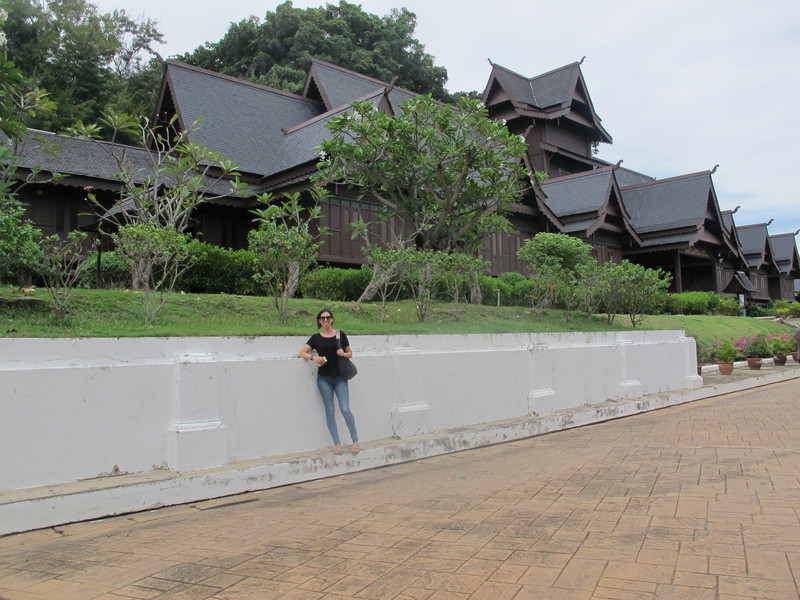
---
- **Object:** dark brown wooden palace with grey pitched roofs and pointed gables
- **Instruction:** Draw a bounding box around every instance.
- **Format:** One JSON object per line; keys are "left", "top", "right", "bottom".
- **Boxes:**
{"left": 7, "top": 60, "right": 800, "bottom": 303}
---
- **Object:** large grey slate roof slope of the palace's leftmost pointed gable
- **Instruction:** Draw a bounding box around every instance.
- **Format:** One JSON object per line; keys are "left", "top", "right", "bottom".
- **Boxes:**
{"left": 158, "top": 61, "right": 324, "bottom": 174}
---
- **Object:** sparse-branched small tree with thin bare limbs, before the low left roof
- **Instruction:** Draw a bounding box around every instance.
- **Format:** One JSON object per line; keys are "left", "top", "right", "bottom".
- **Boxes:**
{"left": 68, "top": 112, "right": 244, "bottom": 323}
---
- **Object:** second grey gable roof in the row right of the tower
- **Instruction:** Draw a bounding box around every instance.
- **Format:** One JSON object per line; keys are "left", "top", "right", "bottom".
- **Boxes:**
{"left": 621, "top": 171, "right": 733, "bottom": 250}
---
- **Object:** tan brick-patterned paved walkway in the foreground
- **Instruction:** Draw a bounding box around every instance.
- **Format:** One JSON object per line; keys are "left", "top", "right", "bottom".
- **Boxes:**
{"left": 0, "top": 372, "right": 800, "bottom": 600}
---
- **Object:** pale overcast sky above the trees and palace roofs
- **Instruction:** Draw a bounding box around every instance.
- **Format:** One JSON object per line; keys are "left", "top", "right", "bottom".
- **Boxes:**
{"left": 94, "top": 0, "right": 800, "bottom": 246}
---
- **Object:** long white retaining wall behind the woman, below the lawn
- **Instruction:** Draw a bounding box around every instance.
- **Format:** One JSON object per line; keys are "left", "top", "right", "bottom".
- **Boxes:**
{"left": 0, "top": 331, "right": 701, "bottom": 500}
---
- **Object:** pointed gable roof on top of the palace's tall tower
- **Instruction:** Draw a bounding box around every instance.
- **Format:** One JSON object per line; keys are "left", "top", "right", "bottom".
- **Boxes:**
{"left": 483, "top": 61, "right": 612, "bottom": 144}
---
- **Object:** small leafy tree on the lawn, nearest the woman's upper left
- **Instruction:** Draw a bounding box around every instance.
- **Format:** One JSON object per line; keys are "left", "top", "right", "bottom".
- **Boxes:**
{"left": 247, "top": 188, "right": 325, "bottom": 321}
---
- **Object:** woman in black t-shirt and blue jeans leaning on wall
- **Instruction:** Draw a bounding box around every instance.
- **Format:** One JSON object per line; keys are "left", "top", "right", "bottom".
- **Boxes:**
{"left": 298, "top": 308, "right": 360, "bottom": 454}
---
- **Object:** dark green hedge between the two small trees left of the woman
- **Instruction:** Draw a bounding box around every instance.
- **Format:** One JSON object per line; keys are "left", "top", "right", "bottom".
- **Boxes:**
{"left": 175, "top": 240, "right": 258, "bottom": 295}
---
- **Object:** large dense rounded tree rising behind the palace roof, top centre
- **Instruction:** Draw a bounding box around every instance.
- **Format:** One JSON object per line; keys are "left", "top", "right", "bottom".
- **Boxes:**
{"left": 180, "top": 0, "right": 447, "bottom": 100}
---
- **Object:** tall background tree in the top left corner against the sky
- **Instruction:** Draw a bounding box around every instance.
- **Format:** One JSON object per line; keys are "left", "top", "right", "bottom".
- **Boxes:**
{"left": 3, "top": 0, "right": 163, "bottom": 131}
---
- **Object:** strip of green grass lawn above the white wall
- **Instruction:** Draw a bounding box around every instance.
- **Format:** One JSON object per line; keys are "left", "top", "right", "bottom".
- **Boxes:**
{"left": 0, "top": 287, "right": 794, "bottom": 356}
